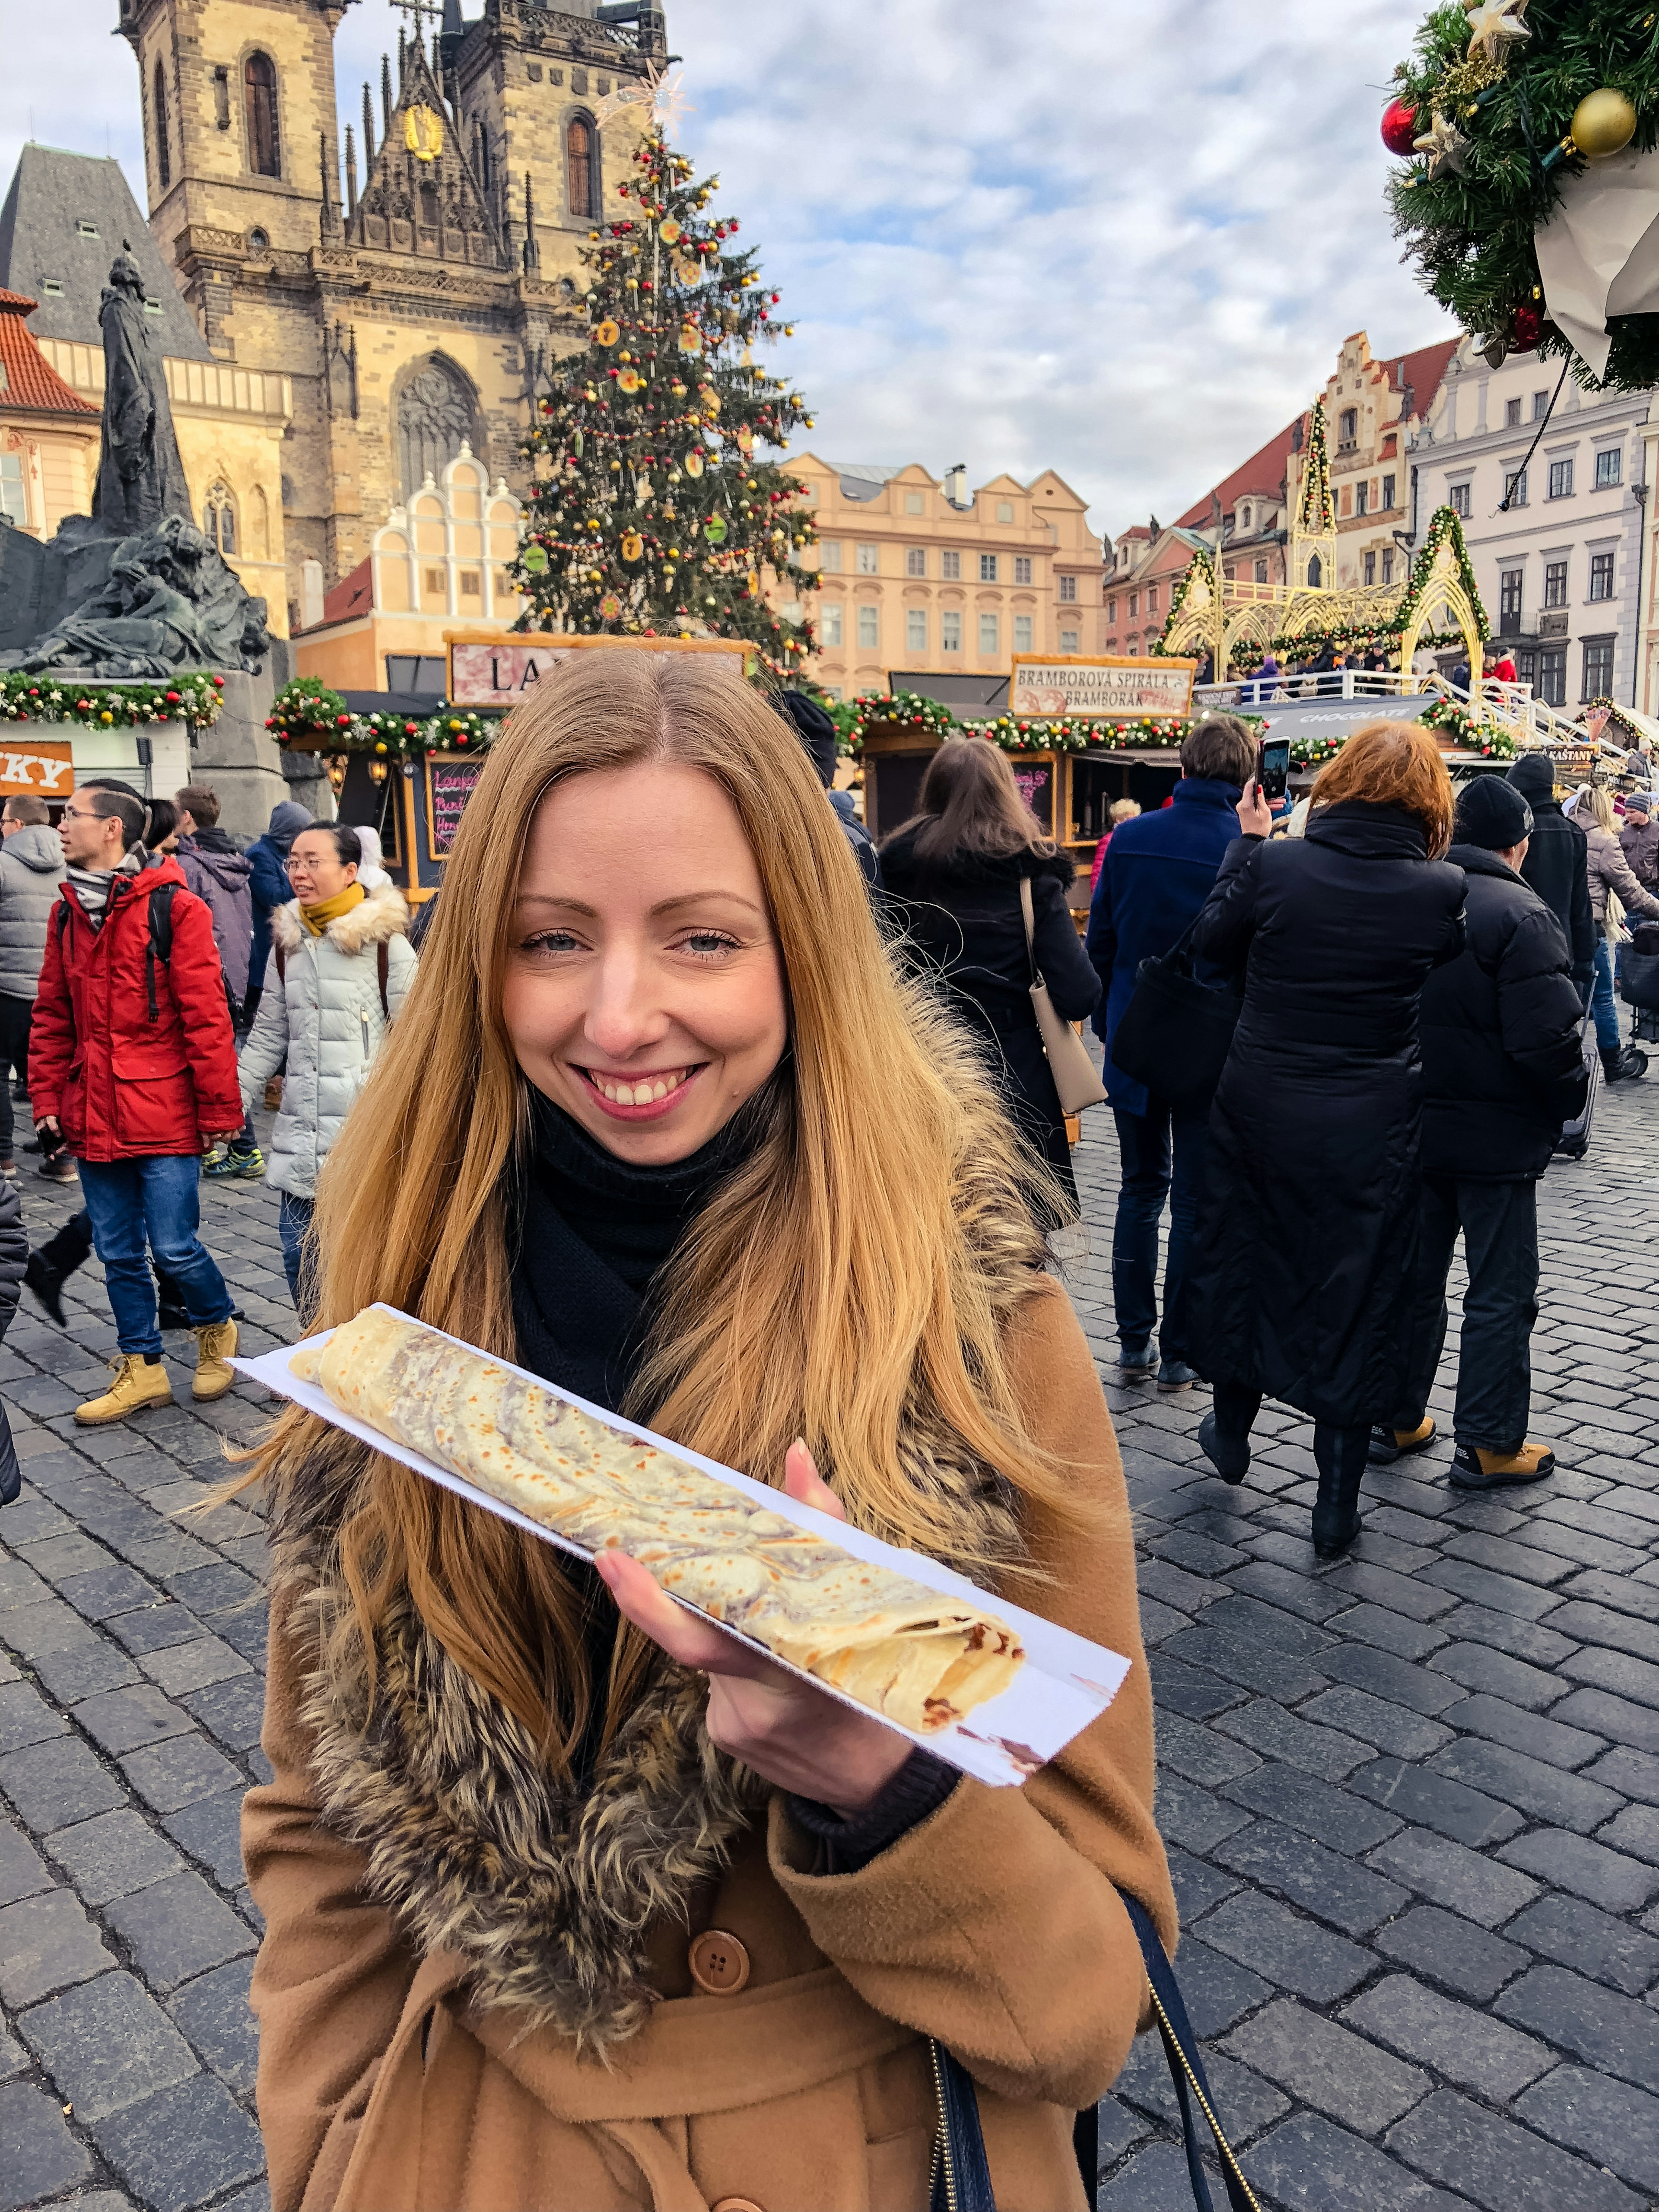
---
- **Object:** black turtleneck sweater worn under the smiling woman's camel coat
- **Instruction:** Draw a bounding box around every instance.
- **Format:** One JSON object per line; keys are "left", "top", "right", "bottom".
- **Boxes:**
{"left": 513, "top": 1090, "right": 956, "bottom": 1874}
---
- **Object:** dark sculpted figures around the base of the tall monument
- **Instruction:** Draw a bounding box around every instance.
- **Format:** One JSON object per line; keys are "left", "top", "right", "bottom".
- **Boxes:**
{"left": 0, "top": 515, "right": 270, "bottom": 681}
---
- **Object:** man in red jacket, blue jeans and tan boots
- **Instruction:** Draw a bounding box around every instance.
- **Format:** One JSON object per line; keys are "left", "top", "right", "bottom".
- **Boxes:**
{"left": 29, "top": 790, "right": 241, "bottom": 1424}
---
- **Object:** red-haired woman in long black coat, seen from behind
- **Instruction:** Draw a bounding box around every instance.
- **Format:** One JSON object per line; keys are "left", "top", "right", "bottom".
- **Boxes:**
{"left": 1188, "top": 721, "right": 1464, "bottom": 1557}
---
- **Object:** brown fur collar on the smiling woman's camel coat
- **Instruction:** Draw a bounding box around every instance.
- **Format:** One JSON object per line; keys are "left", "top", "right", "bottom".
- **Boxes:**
{"left": 272, "top": 1057, "right": 1046, "bottom": 2057}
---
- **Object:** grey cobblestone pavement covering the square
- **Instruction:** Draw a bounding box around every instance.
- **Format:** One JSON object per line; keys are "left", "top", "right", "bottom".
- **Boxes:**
{"left": 0, "top": 1080, "right": 1659, "bottom": 2212}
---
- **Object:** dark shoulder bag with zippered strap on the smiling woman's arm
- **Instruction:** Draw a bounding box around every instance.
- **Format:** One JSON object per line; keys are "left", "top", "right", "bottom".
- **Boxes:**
{"left": 927, "top": 1896, "right": 1261, "bottom": 2212}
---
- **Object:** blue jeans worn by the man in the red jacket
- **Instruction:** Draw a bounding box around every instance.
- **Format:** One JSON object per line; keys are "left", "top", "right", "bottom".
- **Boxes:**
{"left": 79, "top": 1153, "right": 230, "bottom": 1360}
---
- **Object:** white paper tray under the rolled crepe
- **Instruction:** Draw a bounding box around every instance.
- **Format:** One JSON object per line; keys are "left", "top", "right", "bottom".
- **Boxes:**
{"left": 230, "top": 1305, "right": 1130, "bottom": 1785}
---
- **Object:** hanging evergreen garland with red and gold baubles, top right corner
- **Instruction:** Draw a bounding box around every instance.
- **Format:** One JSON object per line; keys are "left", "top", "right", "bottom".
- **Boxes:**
{"left": 1389, "top": 0, "right": 1659, "bottom": 391}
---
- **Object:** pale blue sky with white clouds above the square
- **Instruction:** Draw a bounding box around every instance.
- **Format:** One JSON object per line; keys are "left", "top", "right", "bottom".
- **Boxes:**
{"left": 0, "top": 0, "right": 1446, "bottom": 531}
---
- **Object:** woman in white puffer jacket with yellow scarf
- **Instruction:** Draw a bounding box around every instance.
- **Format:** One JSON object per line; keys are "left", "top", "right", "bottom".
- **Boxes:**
{"left": 241, "top": 823, "right": 416, "bottom": 1325}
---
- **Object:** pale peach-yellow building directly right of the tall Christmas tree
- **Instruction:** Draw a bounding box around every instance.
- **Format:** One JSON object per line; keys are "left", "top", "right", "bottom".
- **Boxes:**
{"left": 790, "top": 454, "right": 1104, "bottom": 699}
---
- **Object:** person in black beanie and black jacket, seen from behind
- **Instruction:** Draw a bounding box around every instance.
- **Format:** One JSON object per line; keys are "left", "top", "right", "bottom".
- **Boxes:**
{"left": 1371, "top": 776, "right": 1588, "bottom": 1491}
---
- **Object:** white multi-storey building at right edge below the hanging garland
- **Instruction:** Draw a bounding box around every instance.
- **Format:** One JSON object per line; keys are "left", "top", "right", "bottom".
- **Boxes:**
{"left": 1407, "top": 338, "right": 1653, "bottom": 715}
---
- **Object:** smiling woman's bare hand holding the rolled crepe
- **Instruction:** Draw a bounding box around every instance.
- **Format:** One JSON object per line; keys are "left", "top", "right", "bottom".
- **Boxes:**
{"left": 593, "top": 1442, "right": 911, "bottom": 1814}
